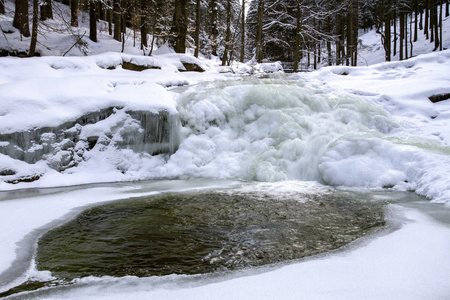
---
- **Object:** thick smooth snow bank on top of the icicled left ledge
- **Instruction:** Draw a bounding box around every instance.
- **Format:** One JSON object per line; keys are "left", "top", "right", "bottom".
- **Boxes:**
{"left": 0, "top": 53, "right": 224, "bottom": 134}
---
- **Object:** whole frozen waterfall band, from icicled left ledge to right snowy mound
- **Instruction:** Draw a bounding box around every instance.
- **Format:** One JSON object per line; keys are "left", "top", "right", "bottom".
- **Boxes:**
{"left": 0, "top": 78, "right": 450, "bottom": 201}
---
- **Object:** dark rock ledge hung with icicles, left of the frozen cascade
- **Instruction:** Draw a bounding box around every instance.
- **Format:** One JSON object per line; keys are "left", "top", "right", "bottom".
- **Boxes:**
{"left": 0, "top": 107, "right": 180, "bottom": 171}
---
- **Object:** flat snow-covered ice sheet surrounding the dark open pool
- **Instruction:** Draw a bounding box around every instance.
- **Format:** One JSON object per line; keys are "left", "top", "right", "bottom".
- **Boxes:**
{"left": 0, "top": 180, "right": 450, "bottom": 299}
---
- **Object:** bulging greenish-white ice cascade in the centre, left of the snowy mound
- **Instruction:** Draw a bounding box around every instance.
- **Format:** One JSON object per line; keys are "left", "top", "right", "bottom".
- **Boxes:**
{"left": 166, "top": 79, "right": 398, "bottom": 182}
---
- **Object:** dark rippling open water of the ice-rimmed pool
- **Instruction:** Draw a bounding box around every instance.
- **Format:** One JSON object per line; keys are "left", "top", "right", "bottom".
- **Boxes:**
{"left": 36, "top": 190, "right": 384, "bottom": 279}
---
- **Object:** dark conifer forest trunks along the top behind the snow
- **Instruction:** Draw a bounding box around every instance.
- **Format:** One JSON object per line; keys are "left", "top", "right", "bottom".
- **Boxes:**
{"left": 0, "top": 0, "right": 449, "bottom": 71}
